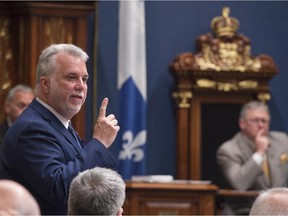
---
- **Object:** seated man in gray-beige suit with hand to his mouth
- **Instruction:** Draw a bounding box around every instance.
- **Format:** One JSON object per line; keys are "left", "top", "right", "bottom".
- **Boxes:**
{"left": 217, "top": 101, "right": 288, "bottom": 215}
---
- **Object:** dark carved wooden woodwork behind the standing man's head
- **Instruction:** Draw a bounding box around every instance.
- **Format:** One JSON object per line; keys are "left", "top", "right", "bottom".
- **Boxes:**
{"left": 0, "top": 1, "right": 95, "bottom": 137}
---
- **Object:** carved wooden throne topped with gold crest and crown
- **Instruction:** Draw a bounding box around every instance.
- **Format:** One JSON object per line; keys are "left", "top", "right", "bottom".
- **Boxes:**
{"left": 170, "top": 7, "right": 278, "bottom": 187}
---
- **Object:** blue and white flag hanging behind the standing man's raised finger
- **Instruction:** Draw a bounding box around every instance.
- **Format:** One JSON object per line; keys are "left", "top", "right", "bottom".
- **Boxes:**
{"left": 116, "top": 0, "right": 147, "bottom": 179}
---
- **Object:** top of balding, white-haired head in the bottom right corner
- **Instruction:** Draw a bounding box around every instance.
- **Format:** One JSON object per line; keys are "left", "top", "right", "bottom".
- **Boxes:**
{"left": 250, "top": 188, "right": 288, "bottom": 215}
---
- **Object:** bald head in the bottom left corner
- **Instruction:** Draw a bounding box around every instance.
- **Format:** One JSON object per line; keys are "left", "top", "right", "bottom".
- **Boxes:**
{"left": 0, "top": 180, "right": 41, "bottom": 215}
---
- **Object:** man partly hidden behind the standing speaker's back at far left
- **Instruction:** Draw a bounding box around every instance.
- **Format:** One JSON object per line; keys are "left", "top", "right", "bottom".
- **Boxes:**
{"left": 0, "top": 84, "right": 34, "bottom": 162}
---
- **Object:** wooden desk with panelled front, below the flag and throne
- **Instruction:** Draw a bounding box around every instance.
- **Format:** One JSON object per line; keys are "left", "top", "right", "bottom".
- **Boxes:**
{"left": 123, "top": 182, "right": 218, "bottom": 215}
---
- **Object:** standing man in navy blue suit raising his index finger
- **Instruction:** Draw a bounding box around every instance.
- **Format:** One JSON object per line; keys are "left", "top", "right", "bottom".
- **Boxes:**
{"left": 2, "top": 44, "right": 119, "bottom": 215}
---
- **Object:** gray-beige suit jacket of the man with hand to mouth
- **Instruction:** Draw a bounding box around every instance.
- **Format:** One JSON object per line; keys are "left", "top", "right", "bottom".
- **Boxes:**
{"left": 217, "top": 131, "right": 288, "bottom": 214}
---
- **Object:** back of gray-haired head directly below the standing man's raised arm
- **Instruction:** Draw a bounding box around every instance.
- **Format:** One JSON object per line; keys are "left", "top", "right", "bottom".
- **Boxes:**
{"left": 68, "top": 167, "right": 125, "bottom": 215}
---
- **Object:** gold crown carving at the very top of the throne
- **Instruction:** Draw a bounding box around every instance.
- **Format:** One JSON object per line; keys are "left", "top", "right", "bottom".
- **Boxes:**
{"left": 211, "top": 7, "right": 240, "bottom": 37}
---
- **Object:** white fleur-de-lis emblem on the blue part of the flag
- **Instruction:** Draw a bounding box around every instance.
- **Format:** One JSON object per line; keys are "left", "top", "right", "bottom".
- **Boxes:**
{"left": 118, "top": 130, "right": 147, "bottom": 162}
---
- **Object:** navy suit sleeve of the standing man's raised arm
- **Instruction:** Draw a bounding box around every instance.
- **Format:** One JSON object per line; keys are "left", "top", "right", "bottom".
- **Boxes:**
{"left": 5, "top": 123, "right": 117, "bottom": 205}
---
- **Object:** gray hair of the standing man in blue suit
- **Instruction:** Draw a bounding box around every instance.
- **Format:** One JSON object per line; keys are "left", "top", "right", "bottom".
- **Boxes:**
{"left": 35, "top": 44, "right": 89, "bottom": 90}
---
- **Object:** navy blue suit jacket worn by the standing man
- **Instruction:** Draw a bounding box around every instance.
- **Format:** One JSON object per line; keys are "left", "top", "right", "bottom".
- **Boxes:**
{"left": 2, "top": 99, "right": 118, "bottom": 215}
